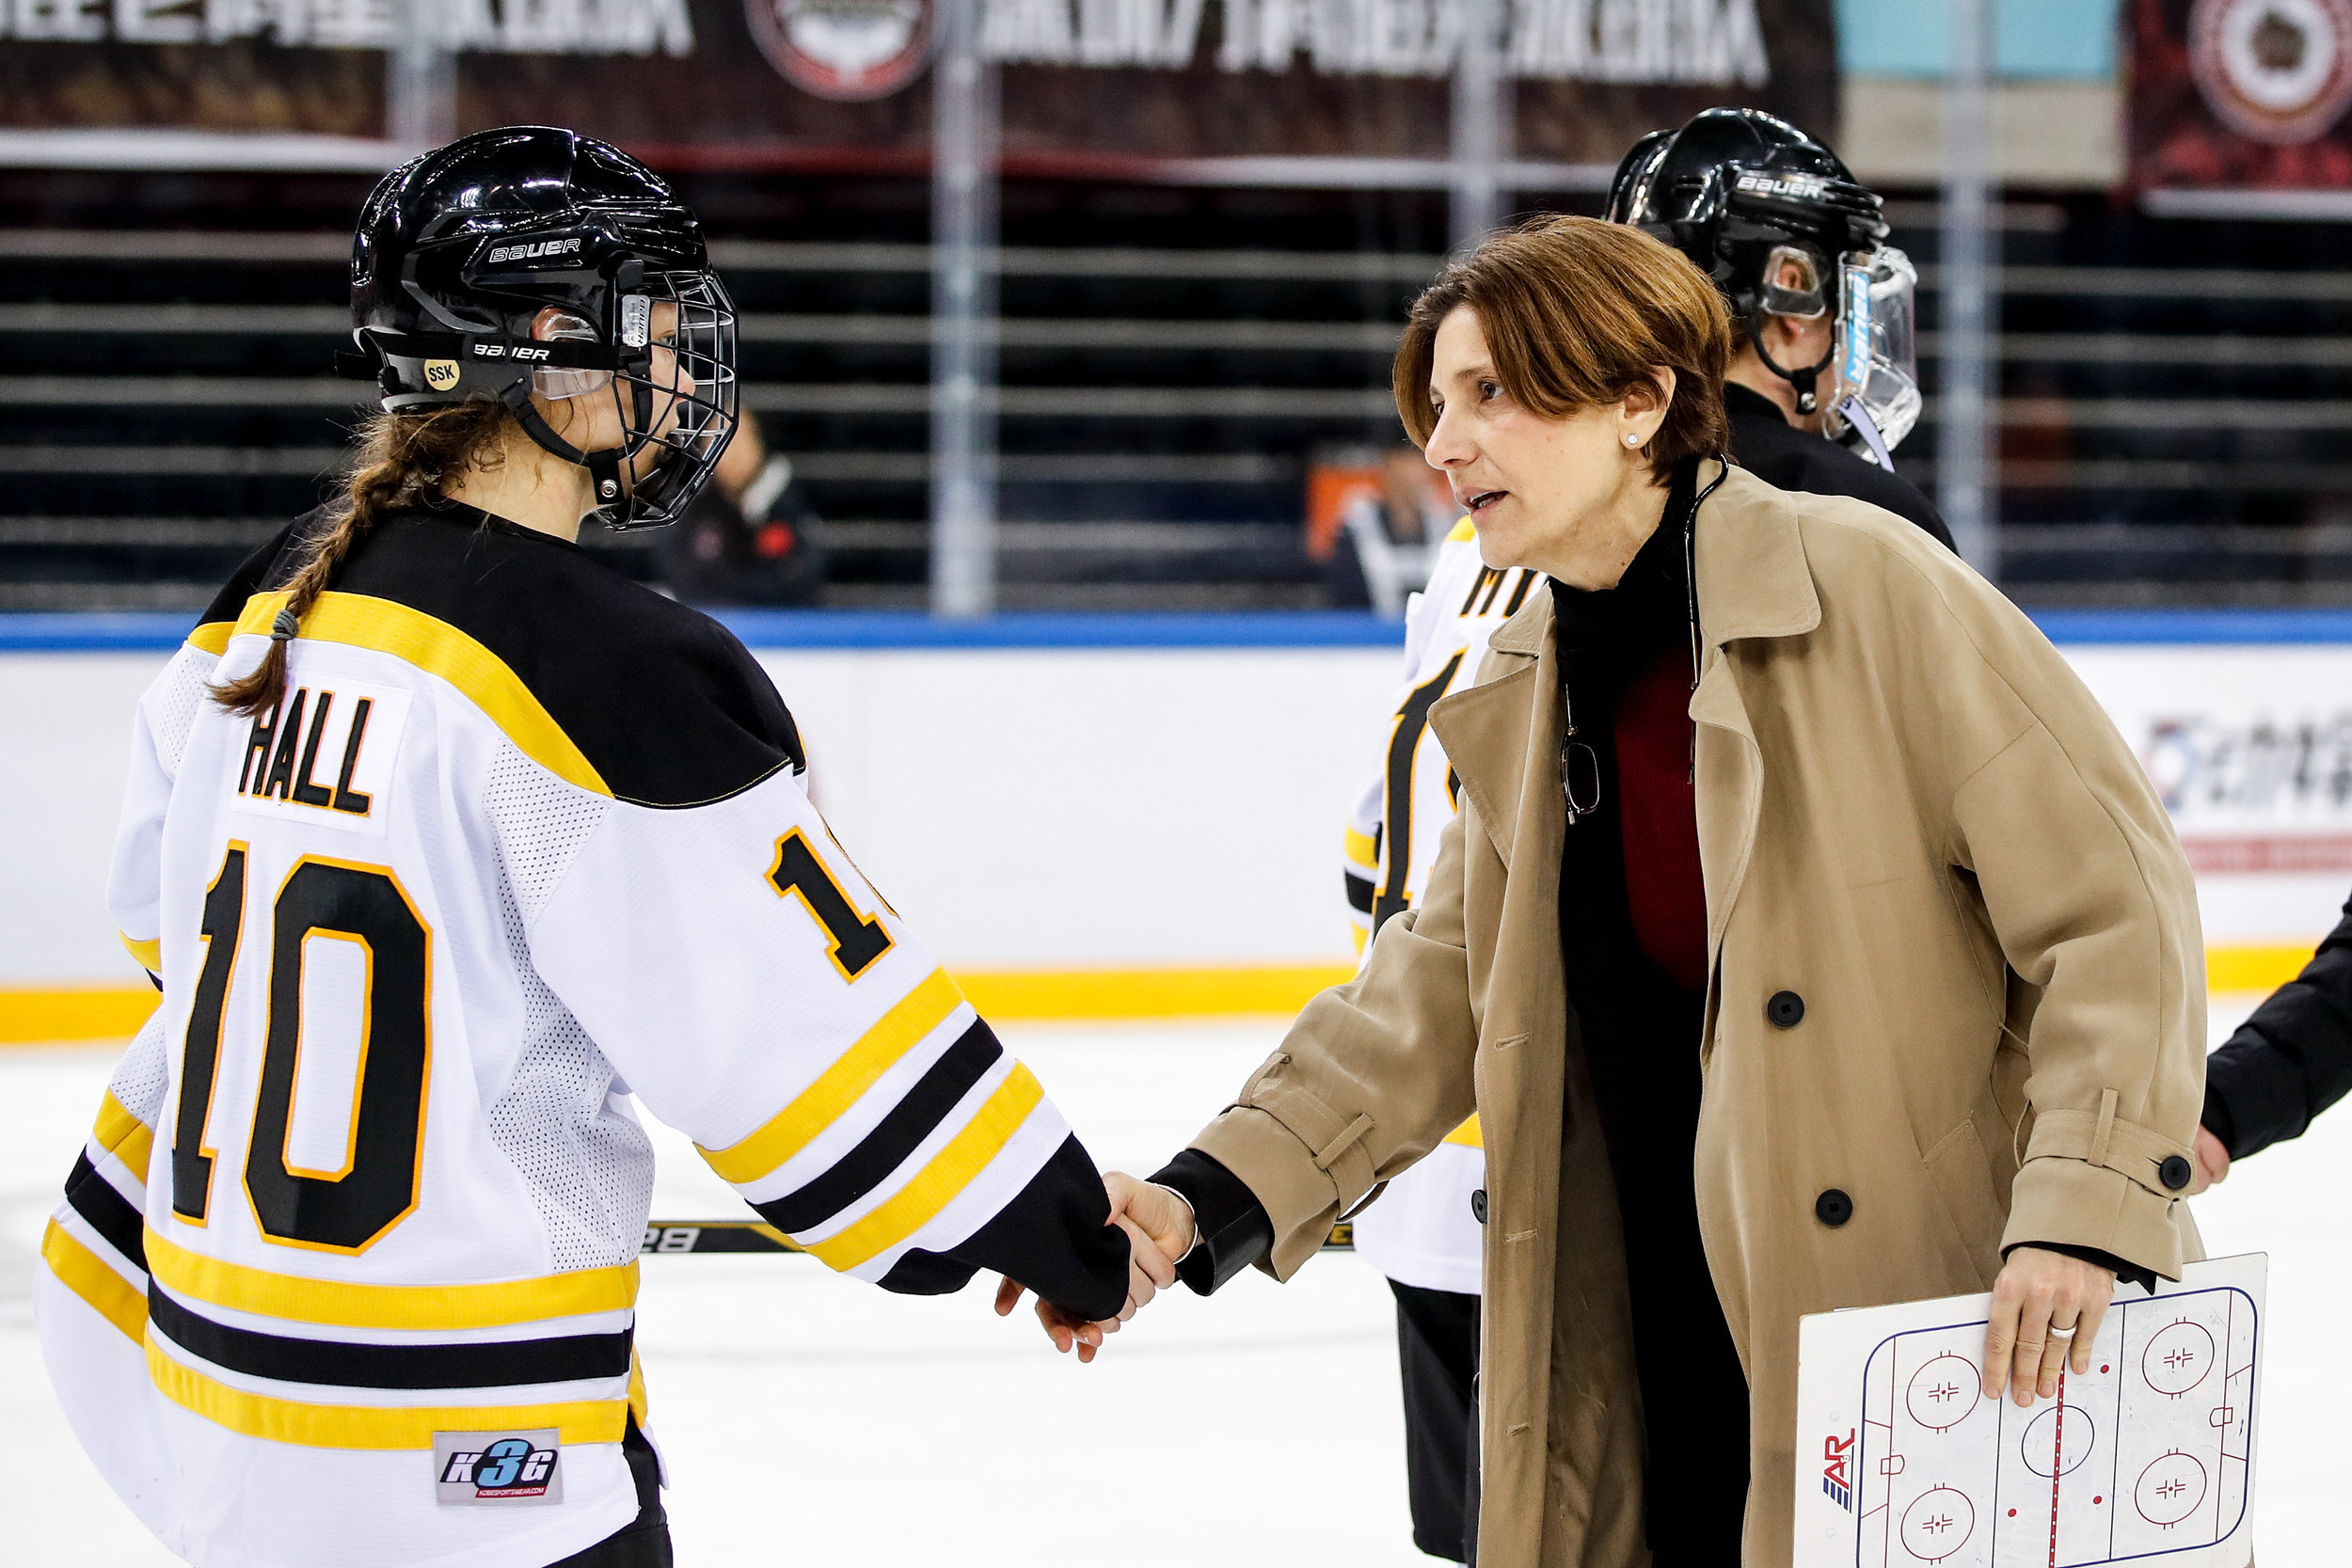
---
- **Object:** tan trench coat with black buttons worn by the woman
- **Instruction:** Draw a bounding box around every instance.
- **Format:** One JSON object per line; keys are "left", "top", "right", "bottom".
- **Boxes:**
{"left": 1195, "top": 470, "right": 2204, "bottom": 1568}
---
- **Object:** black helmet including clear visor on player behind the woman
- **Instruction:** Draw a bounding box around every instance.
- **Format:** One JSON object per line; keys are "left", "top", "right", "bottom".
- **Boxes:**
{"left": 1609, "top": 108, "right": 1919, "bottom": 466}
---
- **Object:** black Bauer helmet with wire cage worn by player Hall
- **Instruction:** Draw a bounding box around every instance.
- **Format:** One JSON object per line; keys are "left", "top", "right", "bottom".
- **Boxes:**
{"left": 337, "top": 124, "right": 737, "bottom": 529}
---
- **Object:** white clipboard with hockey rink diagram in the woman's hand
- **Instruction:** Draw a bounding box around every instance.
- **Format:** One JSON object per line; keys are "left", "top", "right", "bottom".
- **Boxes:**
{"left": 1795, "top": 1253, "right": 2267, "bottom": 1568}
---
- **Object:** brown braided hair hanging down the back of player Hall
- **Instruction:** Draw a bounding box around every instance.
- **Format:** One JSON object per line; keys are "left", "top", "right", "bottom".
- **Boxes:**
{"left": 212, "top": 400, "right": 516, "bottom": 717}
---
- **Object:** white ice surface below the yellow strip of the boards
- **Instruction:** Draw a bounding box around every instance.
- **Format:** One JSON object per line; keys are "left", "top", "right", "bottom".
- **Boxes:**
{"left": 0, "top": 997, "right": 2352, "bottom": 1568}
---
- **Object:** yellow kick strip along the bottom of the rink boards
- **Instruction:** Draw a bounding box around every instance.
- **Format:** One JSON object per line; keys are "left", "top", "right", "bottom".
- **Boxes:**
{"left": 0, "top": 938, "right": 2319, "bottom": 1053}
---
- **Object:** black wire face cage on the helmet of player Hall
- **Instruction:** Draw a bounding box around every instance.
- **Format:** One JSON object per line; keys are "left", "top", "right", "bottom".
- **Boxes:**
{"left": 591, "top": 270, "right": 739, "bottom": 531}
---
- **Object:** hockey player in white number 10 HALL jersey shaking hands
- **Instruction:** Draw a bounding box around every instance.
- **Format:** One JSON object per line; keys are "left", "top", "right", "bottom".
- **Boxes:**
{"left": 38, "top": 127, "right": 1167, "bottom": 1568}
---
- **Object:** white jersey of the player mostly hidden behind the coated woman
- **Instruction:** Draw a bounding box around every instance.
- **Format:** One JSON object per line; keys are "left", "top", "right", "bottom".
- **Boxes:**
{"left": 1343, "top": 517, "right": 1541, "bottom": 1295}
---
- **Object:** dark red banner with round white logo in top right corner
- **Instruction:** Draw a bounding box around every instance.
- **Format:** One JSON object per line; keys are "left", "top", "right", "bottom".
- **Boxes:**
{"left": 2126, "top": 0, "right": 2352, "bottom": 190}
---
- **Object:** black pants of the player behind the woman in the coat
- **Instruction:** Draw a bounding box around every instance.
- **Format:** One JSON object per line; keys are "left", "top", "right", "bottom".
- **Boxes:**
{"left": 1388, "top": 1279, "right": 1480, "bottom": 1563}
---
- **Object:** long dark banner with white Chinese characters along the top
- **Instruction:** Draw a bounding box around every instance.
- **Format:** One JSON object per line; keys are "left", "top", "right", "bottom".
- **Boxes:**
{"left": 0, "top": 0, "right": 1837, "bottom": 166}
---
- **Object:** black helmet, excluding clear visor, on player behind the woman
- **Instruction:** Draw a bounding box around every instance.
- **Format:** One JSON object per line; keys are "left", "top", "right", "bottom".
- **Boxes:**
{"left": 1609, "top": 108, "right": 1886, "bottom": 414}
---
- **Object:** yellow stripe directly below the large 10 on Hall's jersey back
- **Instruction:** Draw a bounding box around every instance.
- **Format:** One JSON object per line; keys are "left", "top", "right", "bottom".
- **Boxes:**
{"left": 146, "top": 1227, "right": 638, "bottom": 1335}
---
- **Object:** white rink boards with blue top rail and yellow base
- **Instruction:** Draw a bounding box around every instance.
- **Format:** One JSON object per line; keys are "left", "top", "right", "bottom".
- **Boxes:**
{"left": 0, "top": 613, "right": 2352, "bottom": 1039}
